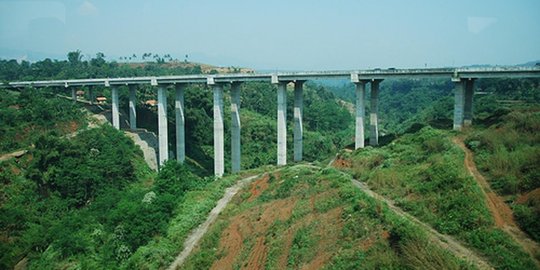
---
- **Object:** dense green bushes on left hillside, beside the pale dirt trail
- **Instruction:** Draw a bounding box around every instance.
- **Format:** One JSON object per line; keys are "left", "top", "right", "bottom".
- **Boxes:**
{"left": 0, "top": 122, "right": 231, "bottom": 269}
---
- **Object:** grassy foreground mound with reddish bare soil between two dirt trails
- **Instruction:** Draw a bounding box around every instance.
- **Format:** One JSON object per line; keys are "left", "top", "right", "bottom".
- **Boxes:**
{"left": 183, "top": 166, "right": 470, "bottom": 269}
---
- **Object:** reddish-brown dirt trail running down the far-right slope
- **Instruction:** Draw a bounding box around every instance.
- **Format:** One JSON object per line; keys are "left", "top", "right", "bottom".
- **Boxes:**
{"left": 452, "top": 137, "right": 540, "bottom": 268}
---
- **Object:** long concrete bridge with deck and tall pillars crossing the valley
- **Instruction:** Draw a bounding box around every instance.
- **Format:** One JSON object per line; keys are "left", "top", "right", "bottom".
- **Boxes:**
{"left": 9, "top": 67, "right": 540, "bottom": 177}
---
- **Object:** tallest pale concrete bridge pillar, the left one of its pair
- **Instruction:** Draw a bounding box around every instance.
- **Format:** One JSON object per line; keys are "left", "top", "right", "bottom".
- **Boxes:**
{"left": 214, "top": 84, "right": 225, "bottom": 177}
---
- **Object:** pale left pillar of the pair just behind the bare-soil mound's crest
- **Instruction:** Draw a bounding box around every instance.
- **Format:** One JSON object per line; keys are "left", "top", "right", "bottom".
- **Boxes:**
{"left": 277, "top": 82, "right": 287, "bottom": 165}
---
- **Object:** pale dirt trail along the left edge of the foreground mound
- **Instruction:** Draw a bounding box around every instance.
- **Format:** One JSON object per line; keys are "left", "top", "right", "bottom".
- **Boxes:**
{"left": 168, "top": 175, "right": 261, "bottom": 270}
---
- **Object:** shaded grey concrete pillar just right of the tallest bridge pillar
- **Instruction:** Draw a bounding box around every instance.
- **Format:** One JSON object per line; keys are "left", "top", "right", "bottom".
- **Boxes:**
{"left": 231, "top": 83, "right": 241, "bottom": 173}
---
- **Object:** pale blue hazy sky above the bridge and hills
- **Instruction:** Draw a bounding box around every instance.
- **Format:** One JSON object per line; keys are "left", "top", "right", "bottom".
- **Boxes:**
{"left": 0, "top": 0, "right": 540, "bottom": 70}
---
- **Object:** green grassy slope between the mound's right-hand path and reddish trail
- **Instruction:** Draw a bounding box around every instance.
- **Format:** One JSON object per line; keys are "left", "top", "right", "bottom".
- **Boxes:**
{"left": 340, "top": 127, "right": 535, "bottom": 269}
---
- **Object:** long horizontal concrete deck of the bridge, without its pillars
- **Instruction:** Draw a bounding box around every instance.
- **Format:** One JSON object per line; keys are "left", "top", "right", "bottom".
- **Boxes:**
{"left": 7, "top": 67, "right": 540, "bottom": 88}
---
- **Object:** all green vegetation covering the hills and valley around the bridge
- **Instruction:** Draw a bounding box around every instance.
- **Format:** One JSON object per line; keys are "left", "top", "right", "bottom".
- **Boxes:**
{"left": 0, "top": 51, "right": 540, "bottom": 269}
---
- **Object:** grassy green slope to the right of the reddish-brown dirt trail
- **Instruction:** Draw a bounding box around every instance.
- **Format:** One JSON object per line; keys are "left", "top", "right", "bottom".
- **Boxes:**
{"left": 466, "top": 107, "right": 540, "bottom": 241}
